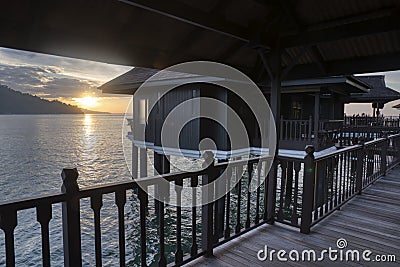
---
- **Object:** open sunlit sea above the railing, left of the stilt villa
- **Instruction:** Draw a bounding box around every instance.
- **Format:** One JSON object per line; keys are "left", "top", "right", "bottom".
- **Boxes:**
{"left": 0, "top": 115, "right": 130, "bottom": 200}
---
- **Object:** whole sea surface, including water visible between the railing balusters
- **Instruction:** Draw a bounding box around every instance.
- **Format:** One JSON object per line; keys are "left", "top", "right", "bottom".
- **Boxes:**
{"left": 0, "top": 115, "right": 263, "bottom": 266}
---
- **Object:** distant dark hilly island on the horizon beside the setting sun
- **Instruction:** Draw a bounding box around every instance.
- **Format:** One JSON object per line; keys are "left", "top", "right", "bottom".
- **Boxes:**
{"left": 0, "top": 85, "right": 108, "bottom": 114}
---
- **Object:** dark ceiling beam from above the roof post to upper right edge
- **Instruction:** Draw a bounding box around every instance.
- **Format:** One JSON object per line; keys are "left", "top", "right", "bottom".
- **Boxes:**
{"left": 281, "top": 9, "right": 400, "bottom": 48}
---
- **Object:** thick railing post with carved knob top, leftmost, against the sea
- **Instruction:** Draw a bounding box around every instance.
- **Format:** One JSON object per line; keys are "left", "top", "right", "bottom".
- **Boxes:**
{"left": 61, "top": 168, "right": 82, "bottom": 267}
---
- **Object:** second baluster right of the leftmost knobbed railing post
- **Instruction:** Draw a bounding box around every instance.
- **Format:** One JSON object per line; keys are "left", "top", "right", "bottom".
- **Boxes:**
{"left": 115, "top": 190, "right": 126, "bottom": 267}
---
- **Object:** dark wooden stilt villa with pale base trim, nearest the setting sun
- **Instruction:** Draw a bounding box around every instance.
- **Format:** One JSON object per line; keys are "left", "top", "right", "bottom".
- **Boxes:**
{"left": 100, "top": 68, "right": 268, "bottom": 159}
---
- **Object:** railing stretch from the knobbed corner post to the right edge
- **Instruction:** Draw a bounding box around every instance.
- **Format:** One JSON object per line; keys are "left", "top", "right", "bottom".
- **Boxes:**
{"left": 300, "top": 134, "right": 400, "bottom": 233}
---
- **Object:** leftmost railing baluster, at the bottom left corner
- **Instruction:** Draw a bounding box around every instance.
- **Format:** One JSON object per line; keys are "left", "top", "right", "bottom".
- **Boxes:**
{"left": 0, "top": 209, "right": 18, "bottom": 267}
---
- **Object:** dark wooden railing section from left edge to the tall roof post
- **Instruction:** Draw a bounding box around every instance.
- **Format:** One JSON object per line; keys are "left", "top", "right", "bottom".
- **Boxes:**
{"left": 0, "top": 157, "right": 275, "bottom": 267}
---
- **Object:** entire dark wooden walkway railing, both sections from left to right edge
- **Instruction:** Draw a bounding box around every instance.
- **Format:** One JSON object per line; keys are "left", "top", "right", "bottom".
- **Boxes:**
{"left": 0, "top": 134, "right": 400, "bottom": 266}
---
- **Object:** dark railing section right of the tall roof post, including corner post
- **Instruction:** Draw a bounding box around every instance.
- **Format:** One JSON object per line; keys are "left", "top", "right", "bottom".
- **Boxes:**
{"left": 276, "top": 134, "right": 400, "bottom": 233}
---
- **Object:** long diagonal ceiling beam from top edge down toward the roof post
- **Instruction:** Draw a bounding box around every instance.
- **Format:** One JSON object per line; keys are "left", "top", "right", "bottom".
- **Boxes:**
{"left": 119, "top": 0, "right": 269, "bottom": 48}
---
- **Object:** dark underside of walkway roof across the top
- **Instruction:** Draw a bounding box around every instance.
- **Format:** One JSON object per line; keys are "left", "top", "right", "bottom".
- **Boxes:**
{"left": 0, "top": 0, "right": 400, "bottom": 82}
